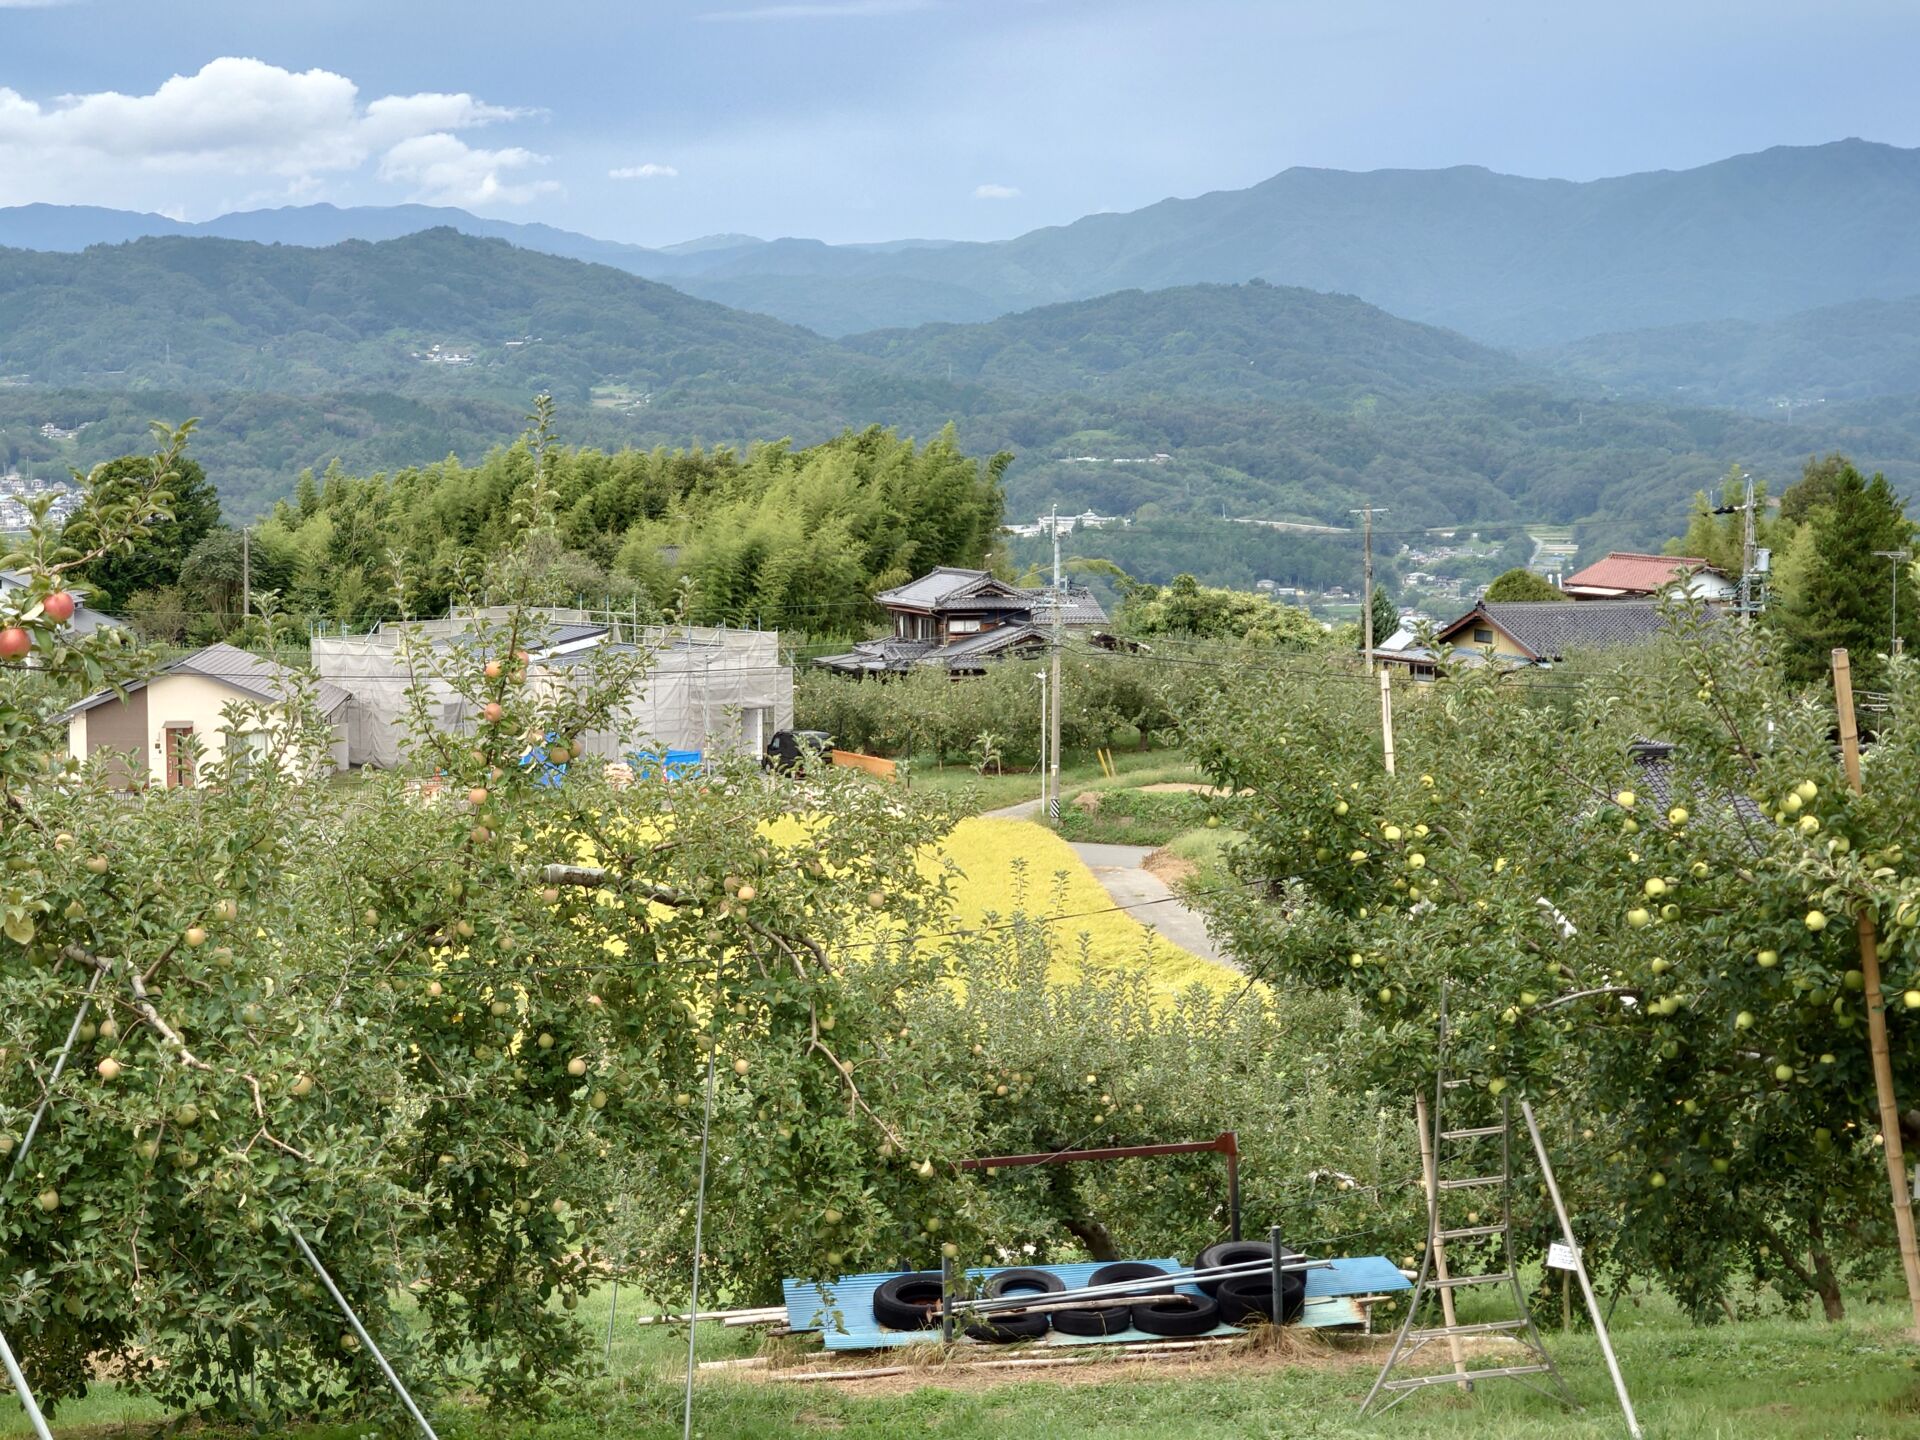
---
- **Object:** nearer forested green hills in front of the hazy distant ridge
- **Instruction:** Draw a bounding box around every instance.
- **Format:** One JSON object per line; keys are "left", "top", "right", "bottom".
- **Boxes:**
{"left": 0, "top": 230, "right": 1920, "bottom": 552}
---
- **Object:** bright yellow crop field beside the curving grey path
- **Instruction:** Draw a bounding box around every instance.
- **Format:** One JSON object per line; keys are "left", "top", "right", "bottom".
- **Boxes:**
{"left": 925, "top": 816, "right": 1244, "bottom": 995}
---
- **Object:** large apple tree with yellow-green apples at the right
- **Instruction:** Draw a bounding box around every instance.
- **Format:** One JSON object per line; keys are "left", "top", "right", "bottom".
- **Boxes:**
{"left": 1187, "top": 607, "right": 1920, "bottom": 1313}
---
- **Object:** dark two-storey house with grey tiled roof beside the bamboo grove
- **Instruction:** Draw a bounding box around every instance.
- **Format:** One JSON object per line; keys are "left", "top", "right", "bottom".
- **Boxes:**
{"left": 814, "top": 564, "right": 1106, "bottom": 676}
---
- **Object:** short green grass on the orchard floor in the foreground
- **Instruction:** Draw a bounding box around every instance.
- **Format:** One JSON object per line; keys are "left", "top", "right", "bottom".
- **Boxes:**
{"left": 26, "top": 1294, "right": 1920, "bottom": 1440}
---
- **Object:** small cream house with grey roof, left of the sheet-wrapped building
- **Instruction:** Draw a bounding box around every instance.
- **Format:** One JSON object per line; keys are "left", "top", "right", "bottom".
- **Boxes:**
{"left": 67, "top": 645, "right": 349, "bottom": 789}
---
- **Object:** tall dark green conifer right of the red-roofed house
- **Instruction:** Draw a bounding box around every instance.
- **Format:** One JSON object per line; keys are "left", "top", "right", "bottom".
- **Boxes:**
{"left": 1774, "top": 455, "right": 1920, "bottom": 687}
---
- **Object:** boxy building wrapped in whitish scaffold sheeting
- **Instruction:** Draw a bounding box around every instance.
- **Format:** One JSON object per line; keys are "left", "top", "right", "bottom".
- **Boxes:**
{"left": 313, "top": 609, "right": 793, "bottom": 768}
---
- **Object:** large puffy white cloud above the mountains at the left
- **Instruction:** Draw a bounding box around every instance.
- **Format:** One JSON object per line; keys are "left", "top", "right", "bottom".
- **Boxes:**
{"left": 0, "top": 60, "right": 540, "bottom": 204}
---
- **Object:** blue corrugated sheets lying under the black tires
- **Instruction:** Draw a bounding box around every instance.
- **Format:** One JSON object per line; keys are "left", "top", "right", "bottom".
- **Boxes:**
{"left": 781, "top": 1256, "right": 1411, "bottom": 1350}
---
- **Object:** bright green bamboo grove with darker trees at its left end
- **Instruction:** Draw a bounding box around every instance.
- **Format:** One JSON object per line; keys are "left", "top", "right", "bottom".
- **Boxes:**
{"left": 69, "top": 416, "right": 1004, "bottom": 643}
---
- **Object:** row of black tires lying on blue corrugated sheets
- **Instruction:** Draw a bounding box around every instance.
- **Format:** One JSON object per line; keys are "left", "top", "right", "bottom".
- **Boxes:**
{"left": 874, "top": 1240, "right": 1308, "bottom": 1344}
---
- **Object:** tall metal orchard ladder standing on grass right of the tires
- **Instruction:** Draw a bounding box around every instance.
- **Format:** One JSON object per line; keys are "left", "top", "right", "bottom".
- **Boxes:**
{"left": 1359, "top": 998, "right": 1580, "bottom": 1415}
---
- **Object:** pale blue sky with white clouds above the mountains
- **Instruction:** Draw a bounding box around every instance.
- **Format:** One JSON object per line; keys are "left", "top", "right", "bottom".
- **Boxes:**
{"left": 0, "top": 0, "right": 1920, "bottom": 244}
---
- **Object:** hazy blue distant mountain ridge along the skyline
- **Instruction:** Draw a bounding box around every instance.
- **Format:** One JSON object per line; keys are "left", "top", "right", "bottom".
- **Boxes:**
{"left": 11, "top": 140, "right": 1920, "bottom": 349}
